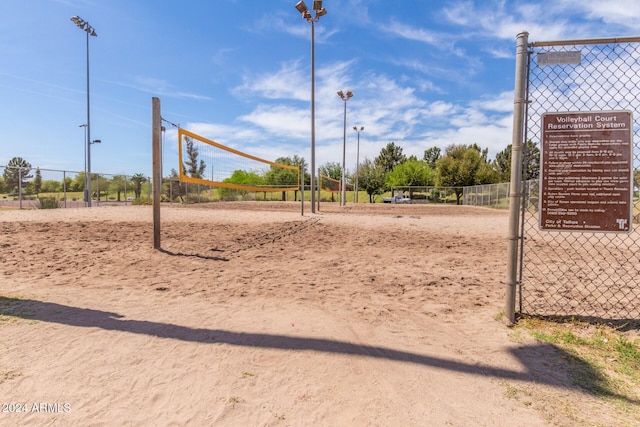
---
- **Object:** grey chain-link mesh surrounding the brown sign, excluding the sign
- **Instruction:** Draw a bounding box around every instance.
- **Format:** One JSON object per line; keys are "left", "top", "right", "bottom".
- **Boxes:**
{"left": 516, "top": 39, "right": 640, "bottom": 321}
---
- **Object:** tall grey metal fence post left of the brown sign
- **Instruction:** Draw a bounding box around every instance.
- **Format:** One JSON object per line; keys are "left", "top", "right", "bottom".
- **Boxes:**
{"left": 504, "top": 31, "right": 529, "bottom": 324}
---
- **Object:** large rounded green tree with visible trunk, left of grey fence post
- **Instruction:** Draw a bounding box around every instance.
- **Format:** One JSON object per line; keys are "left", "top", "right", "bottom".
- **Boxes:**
{"left": 437, "top": 144, "right": 486, "bottom": 204}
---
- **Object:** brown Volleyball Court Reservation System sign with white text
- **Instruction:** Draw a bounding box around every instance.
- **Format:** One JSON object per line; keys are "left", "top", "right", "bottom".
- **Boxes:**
{"left": 540, "top": 111, "right": 633, "bottom": 233}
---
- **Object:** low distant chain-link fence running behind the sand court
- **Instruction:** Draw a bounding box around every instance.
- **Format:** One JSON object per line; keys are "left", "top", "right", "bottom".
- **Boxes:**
{"left": 0, "top": 166, "right": 537, "bottom": 208}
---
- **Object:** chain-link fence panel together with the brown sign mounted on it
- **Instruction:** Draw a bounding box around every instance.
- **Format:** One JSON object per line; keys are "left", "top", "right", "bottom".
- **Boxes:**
{"left": 514, "top": 33, "right": 640, "bottom": 321}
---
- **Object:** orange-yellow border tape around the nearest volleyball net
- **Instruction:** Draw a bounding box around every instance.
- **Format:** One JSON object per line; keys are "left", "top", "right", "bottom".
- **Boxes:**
{"left": 178, "top": 128, "right": 300, "bottom": 192}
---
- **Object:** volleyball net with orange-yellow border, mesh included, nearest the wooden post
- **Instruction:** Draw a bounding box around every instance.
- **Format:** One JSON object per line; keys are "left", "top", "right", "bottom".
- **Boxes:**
{"left": 178, "top": 128, "right": 300, "bottom": 191}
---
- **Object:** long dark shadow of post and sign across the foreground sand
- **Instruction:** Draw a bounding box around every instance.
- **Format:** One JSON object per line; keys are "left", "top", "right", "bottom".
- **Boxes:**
{"left": 0, "top": 296, "right": 640, "bottom": 405}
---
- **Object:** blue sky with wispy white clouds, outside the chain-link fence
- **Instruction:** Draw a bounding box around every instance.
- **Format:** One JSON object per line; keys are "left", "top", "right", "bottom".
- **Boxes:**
{"left": 0, "top": 0, "right": 640, "bottom": 179}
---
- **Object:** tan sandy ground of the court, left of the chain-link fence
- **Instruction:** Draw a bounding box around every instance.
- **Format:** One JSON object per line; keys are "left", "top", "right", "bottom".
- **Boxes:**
{"left": 0, "top": 202, "right": 631, "bottom": 426}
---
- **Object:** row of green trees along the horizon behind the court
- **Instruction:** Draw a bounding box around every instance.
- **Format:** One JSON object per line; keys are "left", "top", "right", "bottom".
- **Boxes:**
{"left": 7, "top": 139, "right": 640, "bottom": 203}
